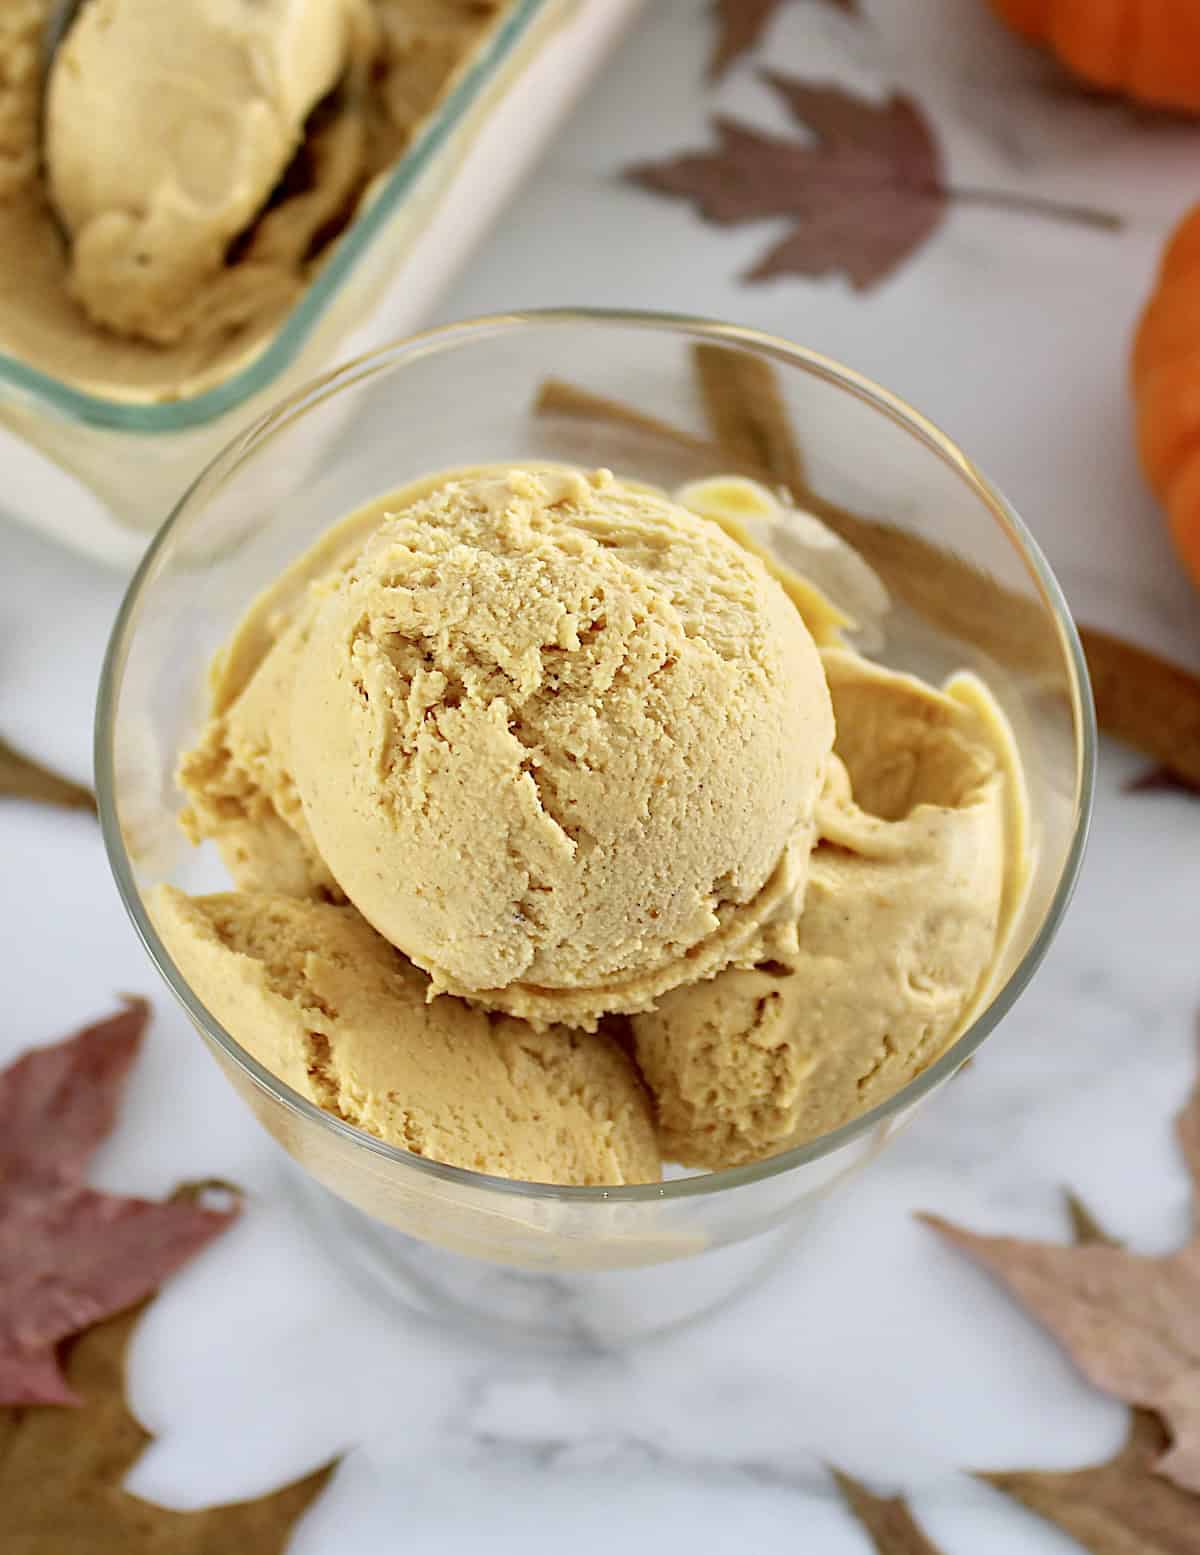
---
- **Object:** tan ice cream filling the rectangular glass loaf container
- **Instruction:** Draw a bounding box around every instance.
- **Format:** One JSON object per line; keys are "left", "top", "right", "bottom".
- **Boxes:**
{"left": 0, "top": 0, "right": 510, "bottom": 403}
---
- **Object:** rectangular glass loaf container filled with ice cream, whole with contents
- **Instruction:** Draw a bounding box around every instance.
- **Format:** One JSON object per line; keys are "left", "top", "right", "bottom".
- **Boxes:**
{"left": 0, "top": 0, "right": 640, "bottom": 564}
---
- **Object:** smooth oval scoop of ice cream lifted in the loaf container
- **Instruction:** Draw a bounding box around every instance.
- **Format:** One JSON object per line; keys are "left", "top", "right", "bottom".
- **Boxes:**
{"left": 44, "top": 0, "right": 361, "bottom": 344}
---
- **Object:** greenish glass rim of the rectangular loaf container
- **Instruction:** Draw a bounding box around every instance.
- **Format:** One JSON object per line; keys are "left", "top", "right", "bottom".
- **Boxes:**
{"left": 0, "top": 0, "right": 547, "bottom": 435}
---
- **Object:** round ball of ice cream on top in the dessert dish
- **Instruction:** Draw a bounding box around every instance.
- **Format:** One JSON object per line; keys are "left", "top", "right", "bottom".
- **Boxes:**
{"left": 291, "top": 470, "right": 833, "bottom": 1026}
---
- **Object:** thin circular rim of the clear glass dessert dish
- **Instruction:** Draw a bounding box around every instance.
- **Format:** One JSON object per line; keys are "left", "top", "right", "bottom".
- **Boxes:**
{"left": 95, "top": 308, "right": 1097, "bottom": 1204}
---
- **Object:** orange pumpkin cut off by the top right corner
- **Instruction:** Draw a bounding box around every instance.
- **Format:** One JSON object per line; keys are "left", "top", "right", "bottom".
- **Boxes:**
{"left": 992, "top": 0, "right": 1200, "bottom": 114}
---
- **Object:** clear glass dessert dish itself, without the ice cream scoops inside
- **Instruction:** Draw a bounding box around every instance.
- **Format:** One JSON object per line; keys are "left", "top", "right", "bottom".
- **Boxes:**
{"left": 96, "top": 311, "right": 1096, "bottom": 1342}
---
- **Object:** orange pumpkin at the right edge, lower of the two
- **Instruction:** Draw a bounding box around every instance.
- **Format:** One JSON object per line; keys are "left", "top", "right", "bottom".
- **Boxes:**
{"left": 1133, "top": 205, "right": 1200, "bottom": 585}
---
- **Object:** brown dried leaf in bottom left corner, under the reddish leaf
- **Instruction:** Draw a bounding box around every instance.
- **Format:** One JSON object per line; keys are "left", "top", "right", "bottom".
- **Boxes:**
{"left": 0, "top": 1308, "right": 333, "bottom": 1555}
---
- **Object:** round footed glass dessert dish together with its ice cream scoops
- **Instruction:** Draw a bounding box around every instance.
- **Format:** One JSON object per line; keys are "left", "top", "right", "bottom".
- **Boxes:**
{"left": 96, "top": 313, "right": 1094, "bottom": 1342}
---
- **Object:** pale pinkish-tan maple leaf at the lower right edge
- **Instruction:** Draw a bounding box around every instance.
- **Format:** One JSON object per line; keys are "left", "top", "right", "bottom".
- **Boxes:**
{"left": 922, "top": 1044, "right": 1200, "bottom": 1491}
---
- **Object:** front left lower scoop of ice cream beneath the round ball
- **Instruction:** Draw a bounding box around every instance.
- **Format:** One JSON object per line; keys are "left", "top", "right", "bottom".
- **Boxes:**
{"left": 151, "top": 886, "right": 659, "bottom": 1186}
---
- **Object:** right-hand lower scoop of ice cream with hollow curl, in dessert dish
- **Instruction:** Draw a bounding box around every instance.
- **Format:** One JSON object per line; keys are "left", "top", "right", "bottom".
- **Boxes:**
{"left": 633, "top": 650, "right": 1023, "bottom": 1168}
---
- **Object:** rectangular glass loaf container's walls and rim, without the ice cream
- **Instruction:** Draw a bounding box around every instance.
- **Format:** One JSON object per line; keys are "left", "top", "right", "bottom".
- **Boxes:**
{"left": 0, "top": 0, "right": 645, "bottom": 566}
